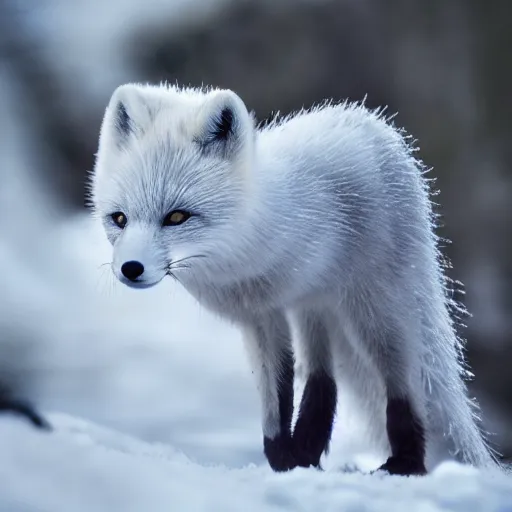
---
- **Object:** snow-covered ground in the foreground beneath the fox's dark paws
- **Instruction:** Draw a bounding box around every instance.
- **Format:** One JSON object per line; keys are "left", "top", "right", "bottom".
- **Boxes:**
{"left": 0, "top": 414, "right": 512, "bottom": 512}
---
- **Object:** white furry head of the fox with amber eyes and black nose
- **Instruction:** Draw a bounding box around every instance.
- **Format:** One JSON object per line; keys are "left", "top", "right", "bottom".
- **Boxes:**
{"left": 90, "top": 84, "right": 255, "bottom": 288}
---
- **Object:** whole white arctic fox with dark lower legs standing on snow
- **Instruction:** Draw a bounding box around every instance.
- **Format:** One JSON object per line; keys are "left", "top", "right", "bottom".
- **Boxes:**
{"left": 91, "top": 84, "right": 495, "bottom": 475}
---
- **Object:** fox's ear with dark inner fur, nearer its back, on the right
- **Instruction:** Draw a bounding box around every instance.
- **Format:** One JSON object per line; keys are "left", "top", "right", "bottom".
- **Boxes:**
{"left": 197, "top": 91, "right": 252, "bottom": 158}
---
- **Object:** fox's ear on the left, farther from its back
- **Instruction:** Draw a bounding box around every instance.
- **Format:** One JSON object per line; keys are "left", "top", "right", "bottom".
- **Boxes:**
{"left": 104, "top": 84, "right": 151, "bottom": 146}
